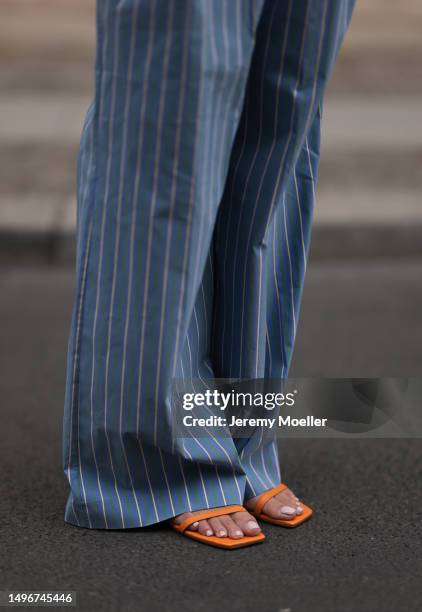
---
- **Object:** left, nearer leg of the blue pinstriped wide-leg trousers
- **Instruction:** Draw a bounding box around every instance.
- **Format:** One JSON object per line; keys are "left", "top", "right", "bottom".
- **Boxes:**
{"left": 64, "top": 0, "right": 259, "bottom": 528}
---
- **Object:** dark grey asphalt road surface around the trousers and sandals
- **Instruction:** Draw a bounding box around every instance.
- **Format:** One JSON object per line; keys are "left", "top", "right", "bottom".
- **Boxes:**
{"left": 0, "top": 260, "right": 422, "bottom": 612}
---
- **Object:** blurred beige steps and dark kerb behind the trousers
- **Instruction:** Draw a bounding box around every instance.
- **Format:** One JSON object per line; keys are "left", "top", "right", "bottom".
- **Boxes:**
{"left": 0, "top": 0, "right": 422, "bottom": 262}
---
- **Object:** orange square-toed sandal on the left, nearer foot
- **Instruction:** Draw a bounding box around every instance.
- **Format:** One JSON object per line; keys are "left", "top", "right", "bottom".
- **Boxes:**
{"left": 170, "top": 506, "right": 265, "bottom": 548}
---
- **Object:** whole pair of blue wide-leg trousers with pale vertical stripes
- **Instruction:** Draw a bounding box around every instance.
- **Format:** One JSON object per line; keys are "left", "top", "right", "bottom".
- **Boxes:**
{"left": 64, "top": 0, "right": 353, "bottom": 528}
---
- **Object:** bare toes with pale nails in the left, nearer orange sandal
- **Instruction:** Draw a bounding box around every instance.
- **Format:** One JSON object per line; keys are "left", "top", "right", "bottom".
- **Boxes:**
{"left": 174, "top": 510, "right": 261, "bottom": 540}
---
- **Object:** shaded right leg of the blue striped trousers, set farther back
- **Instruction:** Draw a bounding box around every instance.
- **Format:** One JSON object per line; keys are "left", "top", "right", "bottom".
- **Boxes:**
{"left": 212, "top": 0, "right": 354, "bottom": 497}
